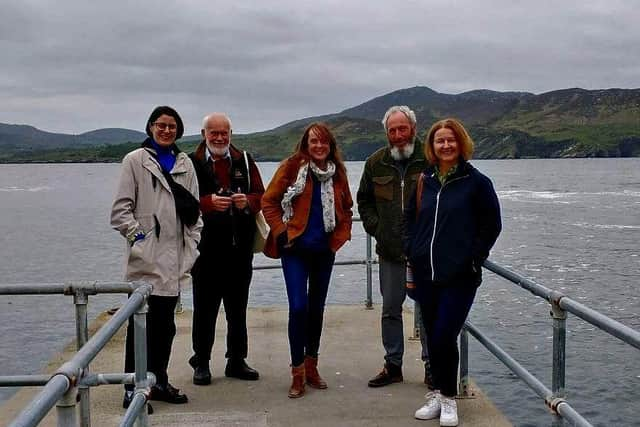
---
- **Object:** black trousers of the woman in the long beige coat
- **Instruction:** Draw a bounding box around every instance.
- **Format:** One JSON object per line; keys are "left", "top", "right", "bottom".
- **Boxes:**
{"left": 124, "top": 295, "right": 179, "bottom": 390}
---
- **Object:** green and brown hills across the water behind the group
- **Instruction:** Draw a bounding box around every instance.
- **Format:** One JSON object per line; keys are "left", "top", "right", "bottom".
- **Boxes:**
{"left": 0, "top": 86, "right": 640, "bottom": 162}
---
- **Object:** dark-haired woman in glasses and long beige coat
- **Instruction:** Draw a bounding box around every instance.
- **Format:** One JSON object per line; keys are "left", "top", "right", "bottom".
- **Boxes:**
{"left": 111, "top": 106, "right": 202, "bottom": 412}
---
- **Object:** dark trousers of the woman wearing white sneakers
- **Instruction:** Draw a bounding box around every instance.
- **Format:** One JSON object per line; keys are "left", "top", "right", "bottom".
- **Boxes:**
{"left": 420, "top": 284, "right": 477, "bottom": 397}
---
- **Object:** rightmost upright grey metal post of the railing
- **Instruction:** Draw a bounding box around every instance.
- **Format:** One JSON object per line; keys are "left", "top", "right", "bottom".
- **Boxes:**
{"left": 550, "top": 291, "right": 567, "bottom": 426}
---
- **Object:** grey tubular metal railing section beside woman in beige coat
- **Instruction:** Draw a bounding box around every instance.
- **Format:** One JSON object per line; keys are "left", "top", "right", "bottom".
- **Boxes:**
{"left": 0, "top": 282, "right": 155, "bottom": 427}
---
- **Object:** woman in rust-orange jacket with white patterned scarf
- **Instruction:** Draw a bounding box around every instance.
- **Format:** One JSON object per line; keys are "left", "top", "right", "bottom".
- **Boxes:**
{"left": 262, "top": 123, "right": 353, "bottom": 398}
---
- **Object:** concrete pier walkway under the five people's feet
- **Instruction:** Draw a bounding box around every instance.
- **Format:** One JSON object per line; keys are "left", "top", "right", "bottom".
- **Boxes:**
{"left": 0, "top": 306, "right": 511, "bottom": 427}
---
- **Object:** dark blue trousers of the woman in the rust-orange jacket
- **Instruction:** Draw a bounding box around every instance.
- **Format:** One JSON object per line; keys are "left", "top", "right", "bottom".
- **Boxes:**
{"left": 281, "top": 249, "right": 335, "bottom": 366}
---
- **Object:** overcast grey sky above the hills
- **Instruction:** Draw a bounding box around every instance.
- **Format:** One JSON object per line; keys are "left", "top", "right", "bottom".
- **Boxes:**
{"left": 0, "top": 0, "right": 640, "bottom": 134}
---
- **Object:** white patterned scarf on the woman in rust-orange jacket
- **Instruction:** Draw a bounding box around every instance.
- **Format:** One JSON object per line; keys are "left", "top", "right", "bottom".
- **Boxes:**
{"left": 280, "top": 160, "right": 336, "bottom": 233}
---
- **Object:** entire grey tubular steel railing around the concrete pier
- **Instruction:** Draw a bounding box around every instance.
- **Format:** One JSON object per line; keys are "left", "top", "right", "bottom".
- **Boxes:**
{"left": 0, "top": 226, "right": 640, "bottom": 427}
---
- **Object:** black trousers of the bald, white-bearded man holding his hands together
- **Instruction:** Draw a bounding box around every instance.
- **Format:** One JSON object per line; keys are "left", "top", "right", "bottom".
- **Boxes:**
{"left": 191, "top": 249, "right": 253, "bottom": 366}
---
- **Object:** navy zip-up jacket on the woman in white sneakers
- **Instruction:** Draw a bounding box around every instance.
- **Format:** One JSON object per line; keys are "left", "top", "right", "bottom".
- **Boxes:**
{"left": 403, "top": 161, "right": 502, "bottom": 286}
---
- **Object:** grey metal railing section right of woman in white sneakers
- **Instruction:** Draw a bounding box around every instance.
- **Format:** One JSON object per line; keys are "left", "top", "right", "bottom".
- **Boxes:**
{"left": 459, "top": 260, "right": 640, "bottom": 426}
